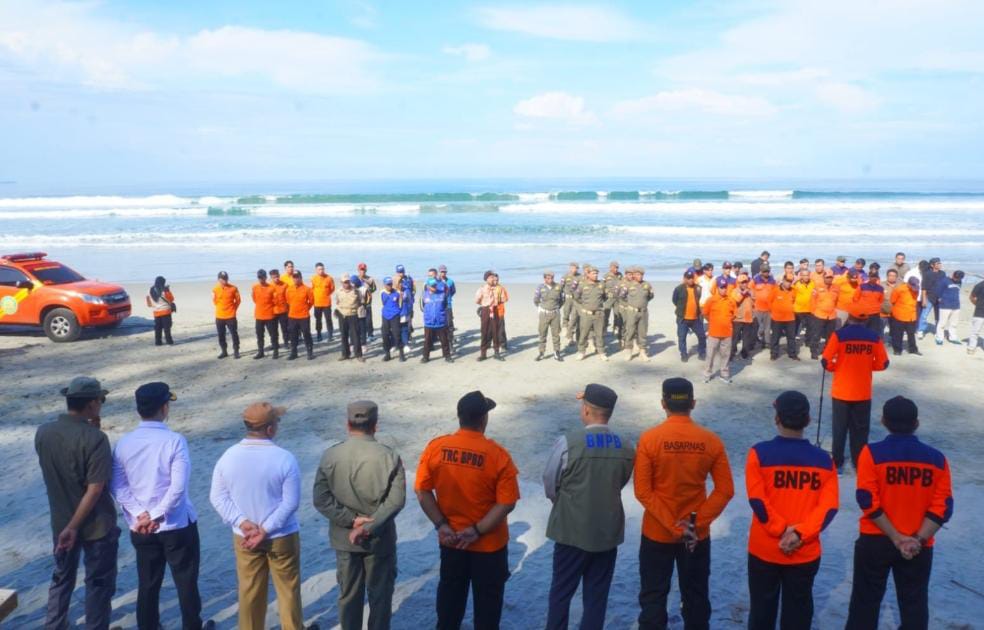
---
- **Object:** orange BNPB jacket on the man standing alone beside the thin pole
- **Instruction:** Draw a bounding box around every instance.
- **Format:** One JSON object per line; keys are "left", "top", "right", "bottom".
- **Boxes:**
{"left": 822, "top": 324, "right": 888, "bottom": 402}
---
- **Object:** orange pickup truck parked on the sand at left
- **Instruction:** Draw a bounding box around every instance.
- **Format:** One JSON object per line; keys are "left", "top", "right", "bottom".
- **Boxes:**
{"left": 0, "top": 252, "right": 130, "bottom": 342}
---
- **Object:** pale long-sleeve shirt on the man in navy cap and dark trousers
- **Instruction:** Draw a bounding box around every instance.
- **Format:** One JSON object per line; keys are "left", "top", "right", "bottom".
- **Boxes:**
{"left": 110, "top": 420, "right": 198, "bottom": 531}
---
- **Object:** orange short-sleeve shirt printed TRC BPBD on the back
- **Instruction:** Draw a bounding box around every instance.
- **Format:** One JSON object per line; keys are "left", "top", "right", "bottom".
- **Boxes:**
{"left": 414, "top": 429, "right": 519, "bottom": 552}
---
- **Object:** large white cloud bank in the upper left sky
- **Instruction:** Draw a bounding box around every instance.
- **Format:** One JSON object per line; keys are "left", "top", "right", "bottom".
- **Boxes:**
{"left": 0, "top": 2, "right": 381, "bottom": 94}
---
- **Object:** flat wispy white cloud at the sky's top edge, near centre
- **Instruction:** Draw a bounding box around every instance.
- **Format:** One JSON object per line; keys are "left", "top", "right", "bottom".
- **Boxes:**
{"left": 478, "top": 4, "right": 642, "bottom": 42}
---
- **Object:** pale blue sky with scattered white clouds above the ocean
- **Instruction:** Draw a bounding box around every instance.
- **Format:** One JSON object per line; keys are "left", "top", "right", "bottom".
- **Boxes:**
{"left": 0, "top": 0, "right": 984, "bottom": 189}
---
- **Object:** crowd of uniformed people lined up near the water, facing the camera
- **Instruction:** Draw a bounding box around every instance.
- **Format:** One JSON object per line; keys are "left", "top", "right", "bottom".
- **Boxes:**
{"left": 140, "top": 251, "right": 984, "bottom": 376}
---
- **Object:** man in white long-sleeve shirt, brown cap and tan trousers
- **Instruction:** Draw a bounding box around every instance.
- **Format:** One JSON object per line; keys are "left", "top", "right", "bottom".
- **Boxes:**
{"left": 209, "top": 402, "right": 304, "bottom": 630}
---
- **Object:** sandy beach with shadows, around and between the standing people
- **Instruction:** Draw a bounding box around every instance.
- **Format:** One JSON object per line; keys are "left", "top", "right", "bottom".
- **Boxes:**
{"left": 0, "top": 284, "right": 984, "bottom": 628}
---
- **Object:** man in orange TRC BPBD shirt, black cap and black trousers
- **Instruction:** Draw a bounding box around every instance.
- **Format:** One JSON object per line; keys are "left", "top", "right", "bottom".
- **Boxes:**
{"left": 414, "top": 391, "right": 519, "bottom": 630}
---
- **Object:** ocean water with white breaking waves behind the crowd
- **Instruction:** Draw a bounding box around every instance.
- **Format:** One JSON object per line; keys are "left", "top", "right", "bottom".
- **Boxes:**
{"left": 0, "top": 179, "right": 984, "bottom": 283}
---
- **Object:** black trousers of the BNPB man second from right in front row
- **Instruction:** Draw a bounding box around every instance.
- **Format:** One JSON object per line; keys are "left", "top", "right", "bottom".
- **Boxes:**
{"left": 748, "top": 554, "right": 820, "bottom": 630}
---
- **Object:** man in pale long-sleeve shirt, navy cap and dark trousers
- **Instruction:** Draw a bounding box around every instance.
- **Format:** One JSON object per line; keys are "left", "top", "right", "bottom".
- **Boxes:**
{"left": 110, "top": 383, "right": 214, "bottom": 630}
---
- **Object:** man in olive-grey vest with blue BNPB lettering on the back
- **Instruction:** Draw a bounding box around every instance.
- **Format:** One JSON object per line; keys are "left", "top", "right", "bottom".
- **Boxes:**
{"left": 543, "top": 383, "right": 635, "bottom": 630}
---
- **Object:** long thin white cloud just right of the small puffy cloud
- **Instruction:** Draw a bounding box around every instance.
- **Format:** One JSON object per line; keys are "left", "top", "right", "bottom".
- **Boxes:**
{"left": 612, "top": 88, "right": 776, "bottom": 117}
